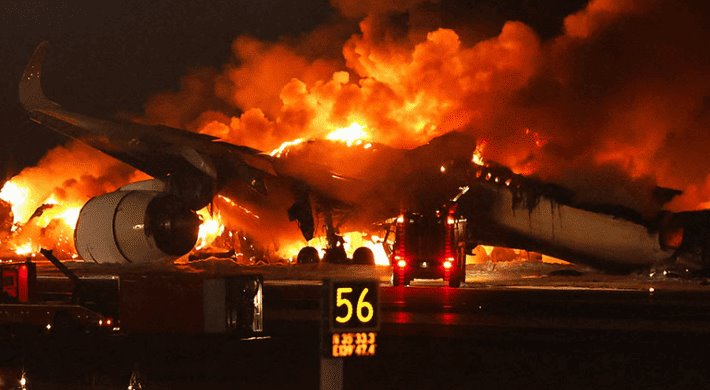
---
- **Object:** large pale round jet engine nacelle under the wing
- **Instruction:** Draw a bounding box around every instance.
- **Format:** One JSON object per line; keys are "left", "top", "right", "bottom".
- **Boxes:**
{"left": 74, "top": 191, "right": 200, "bottom": 263}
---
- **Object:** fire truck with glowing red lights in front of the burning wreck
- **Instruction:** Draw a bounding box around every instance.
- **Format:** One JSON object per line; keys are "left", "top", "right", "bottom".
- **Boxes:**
{"left": 390, "top": 204, "right": 468, "bottom": 287}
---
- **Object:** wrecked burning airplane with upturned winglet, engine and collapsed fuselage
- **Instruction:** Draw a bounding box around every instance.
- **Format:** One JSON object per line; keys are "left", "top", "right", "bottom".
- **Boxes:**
{"left": 12, "top": 44, "right": 710, "bottom": 269}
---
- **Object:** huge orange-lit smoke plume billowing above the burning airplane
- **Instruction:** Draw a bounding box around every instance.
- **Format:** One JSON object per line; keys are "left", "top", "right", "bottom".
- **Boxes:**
{"left": 136, "top": 0, "right": 710, "bottom": 215}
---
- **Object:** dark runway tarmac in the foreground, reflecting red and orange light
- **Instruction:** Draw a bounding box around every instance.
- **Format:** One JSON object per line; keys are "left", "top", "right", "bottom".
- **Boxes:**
{"left": 0, "top": 262, "right": 710, "bottom": 389}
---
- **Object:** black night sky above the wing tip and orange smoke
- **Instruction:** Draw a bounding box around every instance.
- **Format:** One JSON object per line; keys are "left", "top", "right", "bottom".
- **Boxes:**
{"left": 0, "top": 0, "right": 585, "bottom": 179}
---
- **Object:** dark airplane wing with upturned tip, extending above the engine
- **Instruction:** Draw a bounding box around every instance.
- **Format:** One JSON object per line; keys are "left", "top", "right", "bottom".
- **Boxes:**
{"left": 19, "top": 42, "right": 400, "bottom": 244}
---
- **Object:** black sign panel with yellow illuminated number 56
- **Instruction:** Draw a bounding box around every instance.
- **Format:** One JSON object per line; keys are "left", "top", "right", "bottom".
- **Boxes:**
{"left": 326, "top": 280, "right": 380, "bottom": 332}
